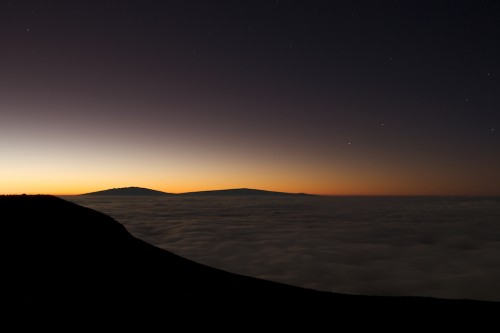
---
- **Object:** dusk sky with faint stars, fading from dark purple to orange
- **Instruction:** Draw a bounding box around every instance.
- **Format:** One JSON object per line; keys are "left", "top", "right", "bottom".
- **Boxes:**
{"left": 0, "top": 0, "right": 500, "bottom": 195}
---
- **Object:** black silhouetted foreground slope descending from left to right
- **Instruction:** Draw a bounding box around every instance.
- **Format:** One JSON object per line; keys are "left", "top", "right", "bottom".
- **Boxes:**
{"left": 0, "top": 196, "right": 499, "bottom": 327}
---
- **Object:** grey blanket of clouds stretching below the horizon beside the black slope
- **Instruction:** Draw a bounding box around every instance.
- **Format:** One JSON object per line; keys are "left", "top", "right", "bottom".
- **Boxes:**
{"left": 64, "top": 196, "right": 500, "bottom": 301}
